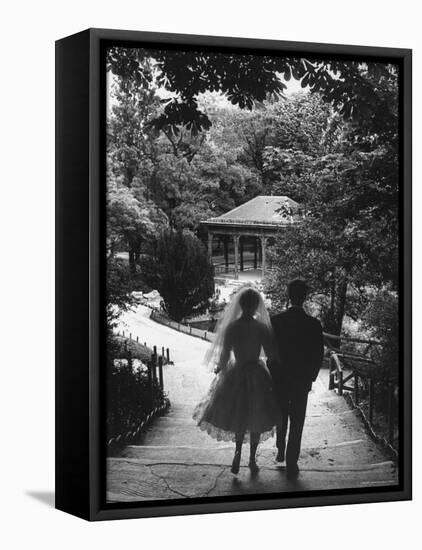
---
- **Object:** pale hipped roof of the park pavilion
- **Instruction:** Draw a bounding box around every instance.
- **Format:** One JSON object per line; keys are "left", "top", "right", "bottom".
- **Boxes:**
{"left": 202, "top": 195, "right": 300, "bottom": 226}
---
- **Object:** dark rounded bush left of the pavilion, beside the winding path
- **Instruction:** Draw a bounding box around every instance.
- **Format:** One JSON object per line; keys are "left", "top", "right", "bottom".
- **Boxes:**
{"left": 142, "top": 231, "right": 214, "bottom": 321}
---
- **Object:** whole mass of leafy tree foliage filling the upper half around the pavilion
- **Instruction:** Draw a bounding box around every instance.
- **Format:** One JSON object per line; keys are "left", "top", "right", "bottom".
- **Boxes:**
{"left": 108, "top": 48, "right": 398, "bottom": 342}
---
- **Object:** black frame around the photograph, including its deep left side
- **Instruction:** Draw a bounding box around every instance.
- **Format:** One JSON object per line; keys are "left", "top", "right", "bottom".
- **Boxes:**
{"left": 56, "top": 29, "right": 412, "bottom": 520}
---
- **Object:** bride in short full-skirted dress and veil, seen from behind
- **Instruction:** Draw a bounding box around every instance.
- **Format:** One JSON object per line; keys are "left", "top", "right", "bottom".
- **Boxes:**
{"left": 193, "top": 287, "right": 278, "bottom": 474}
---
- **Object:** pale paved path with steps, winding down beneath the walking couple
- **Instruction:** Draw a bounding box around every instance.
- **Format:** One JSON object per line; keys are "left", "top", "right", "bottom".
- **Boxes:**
{"left": 107, "top": 306, "right": 397, "bottom": 502}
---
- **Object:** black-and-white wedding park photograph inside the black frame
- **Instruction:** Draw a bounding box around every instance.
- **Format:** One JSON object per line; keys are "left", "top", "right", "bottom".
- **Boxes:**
{"left": 102, "top": 42, "right": 404, "bottom": 505}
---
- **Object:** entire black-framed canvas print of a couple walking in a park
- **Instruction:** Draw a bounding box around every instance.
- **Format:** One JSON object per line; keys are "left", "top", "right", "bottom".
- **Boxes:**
{"left": 56, "top": 29, "right": 411, "bottom": 520}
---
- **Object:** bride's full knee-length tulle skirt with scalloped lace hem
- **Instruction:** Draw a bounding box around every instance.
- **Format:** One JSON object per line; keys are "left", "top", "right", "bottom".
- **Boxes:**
{"left": 193, "top": 361, "right": 279, "bottom": 441}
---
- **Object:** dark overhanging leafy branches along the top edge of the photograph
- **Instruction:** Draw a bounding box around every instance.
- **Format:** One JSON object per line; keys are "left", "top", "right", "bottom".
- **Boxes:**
{"left": 107, "top": 47, "right": 398, "bottom": 140}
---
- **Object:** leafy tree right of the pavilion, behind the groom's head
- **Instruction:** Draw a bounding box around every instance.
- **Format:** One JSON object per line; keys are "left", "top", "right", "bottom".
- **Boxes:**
{"left": 267, "top": 151, "right": 398, "bottom": 334}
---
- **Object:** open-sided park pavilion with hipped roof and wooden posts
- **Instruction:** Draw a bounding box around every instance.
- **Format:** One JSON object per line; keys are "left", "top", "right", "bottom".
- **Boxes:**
{"left": 201, "top": 195, "right": 303, "bottom": 279}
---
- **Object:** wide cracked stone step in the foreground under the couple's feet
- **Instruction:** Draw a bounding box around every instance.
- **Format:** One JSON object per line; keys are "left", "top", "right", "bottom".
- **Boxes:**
{"left": 107, "top": 456, "right": 397, "bottom": 502}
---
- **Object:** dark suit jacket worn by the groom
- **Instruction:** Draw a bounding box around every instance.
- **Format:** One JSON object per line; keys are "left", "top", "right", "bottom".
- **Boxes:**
{"left": 268, "top": 306, "right": 324, "bottom": 394}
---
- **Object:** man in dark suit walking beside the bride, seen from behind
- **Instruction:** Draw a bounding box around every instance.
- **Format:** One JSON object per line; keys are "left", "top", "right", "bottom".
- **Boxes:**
{"left": 269, "top": 279, "right": 324, "bottom": 477}
